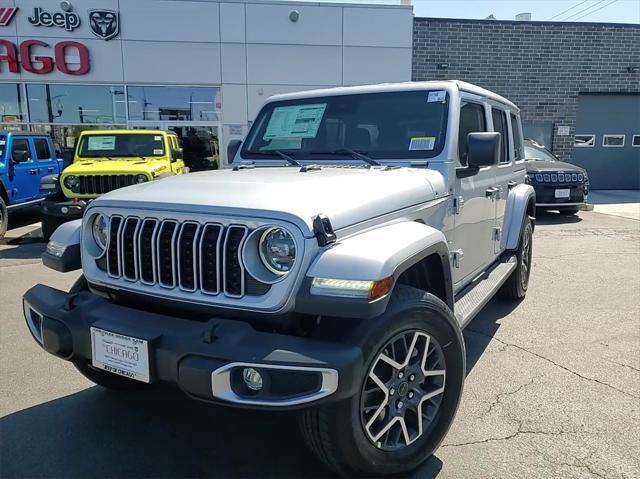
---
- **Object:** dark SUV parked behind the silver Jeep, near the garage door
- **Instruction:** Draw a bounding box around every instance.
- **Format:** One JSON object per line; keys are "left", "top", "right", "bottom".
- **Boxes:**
{"left": 524, "top": 140, "right": 589, "bottom": 215}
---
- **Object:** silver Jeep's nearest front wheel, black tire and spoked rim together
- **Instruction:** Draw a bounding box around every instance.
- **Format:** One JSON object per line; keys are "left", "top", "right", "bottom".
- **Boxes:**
{"left": 301, "top": 285, "right": 465, "bottom": 476}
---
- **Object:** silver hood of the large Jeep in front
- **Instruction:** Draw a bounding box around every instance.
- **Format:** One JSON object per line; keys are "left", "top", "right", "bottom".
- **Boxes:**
{"left": 95, "top": 166, "right": 447, "bottom": 235}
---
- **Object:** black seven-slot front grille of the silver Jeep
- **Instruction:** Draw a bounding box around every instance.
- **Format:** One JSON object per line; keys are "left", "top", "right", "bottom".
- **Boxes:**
{"left": 105, "top": 216, "right": 249, "bottom": 298}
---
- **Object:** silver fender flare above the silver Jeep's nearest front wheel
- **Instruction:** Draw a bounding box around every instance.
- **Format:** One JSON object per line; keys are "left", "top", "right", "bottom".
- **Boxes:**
{"left": 295, "top": 221, "right": 453, "bottom": 318}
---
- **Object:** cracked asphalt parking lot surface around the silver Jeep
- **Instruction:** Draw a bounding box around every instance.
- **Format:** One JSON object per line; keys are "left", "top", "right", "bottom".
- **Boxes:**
{"left": 0, "top": 208, "right": 640, "bottom": 479}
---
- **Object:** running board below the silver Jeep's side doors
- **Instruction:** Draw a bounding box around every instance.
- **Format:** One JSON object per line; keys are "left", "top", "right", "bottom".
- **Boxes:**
{"left": 454, "top": 256, "right": 517, "bottom": 328}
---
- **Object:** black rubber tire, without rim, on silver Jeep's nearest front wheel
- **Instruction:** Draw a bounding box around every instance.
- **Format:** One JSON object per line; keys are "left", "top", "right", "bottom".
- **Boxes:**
{"left": 300, "top": 285, "right": 465, "bottom": 477}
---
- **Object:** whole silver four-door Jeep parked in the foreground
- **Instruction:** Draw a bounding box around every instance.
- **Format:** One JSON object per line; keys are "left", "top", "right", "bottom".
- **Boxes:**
{"left": 24, "top": 81, "right": 535, "bottom": 476}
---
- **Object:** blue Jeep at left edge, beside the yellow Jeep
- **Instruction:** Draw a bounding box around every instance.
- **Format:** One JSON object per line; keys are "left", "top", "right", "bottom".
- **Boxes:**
{"left": 0, "top": 131, "right": 65, "bottom": 239}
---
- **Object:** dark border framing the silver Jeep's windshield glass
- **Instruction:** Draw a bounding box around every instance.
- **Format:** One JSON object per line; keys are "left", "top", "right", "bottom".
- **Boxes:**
{"left": 240, "top": 88, "right": 455, "bottom": 164}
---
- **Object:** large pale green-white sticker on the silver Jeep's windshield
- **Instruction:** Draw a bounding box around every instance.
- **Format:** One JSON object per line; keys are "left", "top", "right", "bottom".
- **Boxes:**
{"left": 262, "top": 103, "right": 327, "bottom": 140}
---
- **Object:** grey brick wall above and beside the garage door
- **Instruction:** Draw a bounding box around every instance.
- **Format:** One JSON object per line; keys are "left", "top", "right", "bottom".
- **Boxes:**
{"left": 412, "top": 18, "right": 640, "bottom": 160}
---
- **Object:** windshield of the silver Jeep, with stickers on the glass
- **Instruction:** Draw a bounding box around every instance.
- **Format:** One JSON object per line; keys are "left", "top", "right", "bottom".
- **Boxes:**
{"left": 242, "top": 90, "right": 449, "bottom": 162}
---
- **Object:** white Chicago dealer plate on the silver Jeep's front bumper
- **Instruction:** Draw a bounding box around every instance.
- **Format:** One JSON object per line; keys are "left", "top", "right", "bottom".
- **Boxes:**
{"left": 91, "top": 328, "right": 150, "bottom": 383}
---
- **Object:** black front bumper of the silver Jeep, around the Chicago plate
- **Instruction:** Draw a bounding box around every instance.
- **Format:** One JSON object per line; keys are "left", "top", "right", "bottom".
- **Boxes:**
{"left": 24, "top": 285, "right": 364, "bottom": 409}
